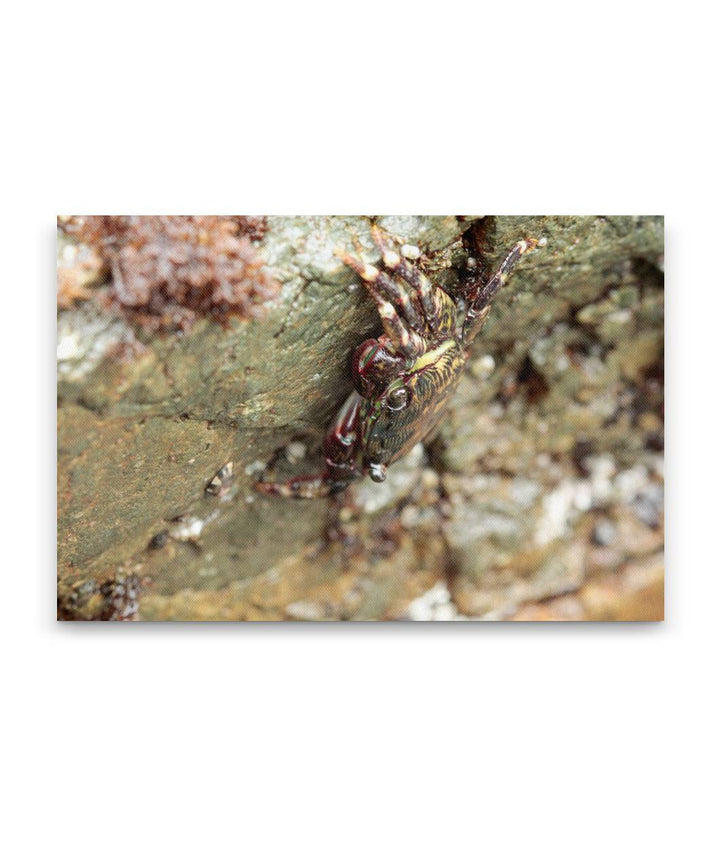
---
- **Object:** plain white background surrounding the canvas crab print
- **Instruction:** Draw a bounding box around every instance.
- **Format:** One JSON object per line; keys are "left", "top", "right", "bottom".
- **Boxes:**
{"left": 0, "top": 0, "right": 720, "bottom": 856}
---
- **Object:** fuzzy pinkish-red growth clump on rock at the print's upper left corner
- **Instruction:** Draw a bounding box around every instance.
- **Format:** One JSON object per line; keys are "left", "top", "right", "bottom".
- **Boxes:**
{"left": 60, "top": 216, "right": 279, "bottom": 331}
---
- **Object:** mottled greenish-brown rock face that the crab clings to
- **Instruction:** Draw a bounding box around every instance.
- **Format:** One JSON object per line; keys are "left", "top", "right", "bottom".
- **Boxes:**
{"left": 58, "top": 216, "right": 663, "bottom": 620}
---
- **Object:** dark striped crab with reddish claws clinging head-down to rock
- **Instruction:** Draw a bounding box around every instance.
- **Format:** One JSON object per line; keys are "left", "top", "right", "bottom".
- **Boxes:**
{"left": 255, "top": 226, "right": 544, "bottom": 499}
